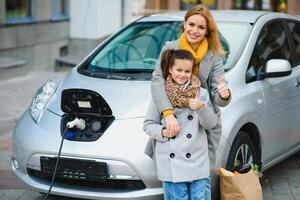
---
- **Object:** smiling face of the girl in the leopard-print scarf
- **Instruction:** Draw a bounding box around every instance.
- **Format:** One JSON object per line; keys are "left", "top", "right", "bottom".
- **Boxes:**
{"left": 169, "top": 58, "right": 194, "bottom": 85}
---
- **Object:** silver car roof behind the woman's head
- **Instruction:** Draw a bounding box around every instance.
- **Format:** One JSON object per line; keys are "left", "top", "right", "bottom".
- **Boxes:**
{"left": 138, "top": 10, "right": 296, "bottom": 23}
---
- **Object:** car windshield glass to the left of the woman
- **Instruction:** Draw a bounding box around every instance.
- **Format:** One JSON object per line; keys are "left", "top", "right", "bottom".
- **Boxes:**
{"left": 87, "top": 22, "right": 181, "bottom": 78}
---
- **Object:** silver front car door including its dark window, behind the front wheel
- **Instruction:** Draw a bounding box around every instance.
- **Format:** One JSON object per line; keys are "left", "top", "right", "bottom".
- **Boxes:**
{"left": 246, "top": 20, "right": 295, "bottom": 162}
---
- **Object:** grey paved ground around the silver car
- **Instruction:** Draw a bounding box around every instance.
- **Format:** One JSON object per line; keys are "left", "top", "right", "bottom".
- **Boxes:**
{"left": 0, "top": 71, "right": 300, "bottom": 200}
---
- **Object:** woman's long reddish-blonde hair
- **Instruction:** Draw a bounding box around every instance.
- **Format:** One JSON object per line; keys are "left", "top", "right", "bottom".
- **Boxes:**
{"left": 183, "top": 4, "right": 225, "bottom": 57}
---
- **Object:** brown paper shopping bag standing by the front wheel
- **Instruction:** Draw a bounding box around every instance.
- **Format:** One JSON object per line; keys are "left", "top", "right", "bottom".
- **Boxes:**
{"left": 220, "top": 169, "right": 263, "bottom": 200}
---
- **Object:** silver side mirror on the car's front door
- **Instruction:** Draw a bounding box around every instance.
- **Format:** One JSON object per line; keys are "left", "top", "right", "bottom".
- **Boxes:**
{"left": 258, "top": 59, "right": 292, "bottom": 80}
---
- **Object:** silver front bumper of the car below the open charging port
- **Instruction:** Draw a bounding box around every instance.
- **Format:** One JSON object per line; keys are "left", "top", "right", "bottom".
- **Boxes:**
{"left": 12, "top": 111, "right": 163, "bottom": 200}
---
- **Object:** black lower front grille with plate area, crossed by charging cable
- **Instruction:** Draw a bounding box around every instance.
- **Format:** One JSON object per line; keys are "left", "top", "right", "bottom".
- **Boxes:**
{"left": 27, "top": 157, "right": 146, "bottom": 189}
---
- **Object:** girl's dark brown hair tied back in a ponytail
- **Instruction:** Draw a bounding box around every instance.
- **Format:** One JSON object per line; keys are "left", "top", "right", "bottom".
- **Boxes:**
{"left": 160, "top": 49, "right": 195, "bottom": 79}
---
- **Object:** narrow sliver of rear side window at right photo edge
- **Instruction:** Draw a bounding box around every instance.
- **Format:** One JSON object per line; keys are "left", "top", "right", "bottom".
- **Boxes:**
{"left": 288, "top": 22, "right": 300, "bottom": 65}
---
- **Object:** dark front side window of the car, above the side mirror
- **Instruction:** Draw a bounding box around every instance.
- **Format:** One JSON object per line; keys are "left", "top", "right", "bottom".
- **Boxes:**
{"left": 246, "top": 21, "right": 291, "bottom": 83}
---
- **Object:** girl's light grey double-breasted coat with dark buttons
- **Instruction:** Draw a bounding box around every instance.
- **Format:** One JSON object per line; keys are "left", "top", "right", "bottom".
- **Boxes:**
{"left": 144, "top": 88, "right": 217, "bottom": 182}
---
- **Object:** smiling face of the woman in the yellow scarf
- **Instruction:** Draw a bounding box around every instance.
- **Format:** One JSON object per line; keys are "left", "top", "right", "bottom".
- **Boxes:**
{"left": 183, "top": 14, "right": 207, "bottom": 44}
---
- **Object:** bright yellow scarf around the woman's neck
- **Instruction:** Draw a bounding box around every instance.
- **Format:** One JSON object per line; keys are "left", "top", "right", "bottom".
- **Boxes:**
{"left": 179, "top": 33, "right": 208, "bottom": 76}
